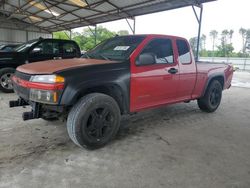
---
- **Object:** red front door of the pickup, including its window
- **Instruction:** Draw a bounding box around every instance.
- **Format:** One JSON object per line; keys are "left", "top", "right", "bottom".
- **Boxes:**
{"left": 130, "top": 38, "right": 179, "bottom": 112}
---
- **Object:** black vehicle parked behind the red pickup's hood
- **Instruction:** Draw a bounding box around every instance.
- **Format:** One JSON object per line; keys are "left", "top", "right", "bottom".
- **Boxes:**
{"left": 0, "top": 38, "right": 81, "bottom": 93}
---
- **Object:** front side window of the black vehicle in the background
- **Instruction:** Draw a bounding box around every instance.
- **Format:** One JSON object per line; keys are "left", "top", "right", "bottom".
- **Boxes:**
{"left": 31, "top": 41, "right": 59, "bottom": 54}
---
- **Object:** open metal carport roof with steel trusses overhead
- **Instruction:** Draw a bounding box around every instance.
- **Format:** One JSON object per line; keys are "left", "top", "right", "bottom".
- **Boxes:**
{"left": 0, "top": 0, "right": 214, "bottom": 58}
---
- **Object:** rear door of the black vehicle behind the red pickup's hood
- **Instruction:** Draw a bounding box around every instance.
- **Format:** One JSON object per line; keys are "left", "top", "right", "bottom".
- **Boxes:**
{"left": 62, "top": 41, "right": 80, "bottom": 59}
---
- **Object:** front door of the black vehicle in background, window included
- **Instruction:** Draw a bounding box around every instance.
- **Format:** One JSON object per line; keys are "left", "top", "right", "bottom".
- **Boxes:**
{"left": 28, "top": 40, "right": 60, "bottom": 62}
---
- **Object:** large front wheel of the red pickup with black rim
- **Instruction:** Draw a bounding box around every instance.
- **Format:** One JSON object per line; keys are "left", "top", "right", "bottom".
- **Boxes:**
{"left": 67, "top": 93, "right": 121, "bottom": 149}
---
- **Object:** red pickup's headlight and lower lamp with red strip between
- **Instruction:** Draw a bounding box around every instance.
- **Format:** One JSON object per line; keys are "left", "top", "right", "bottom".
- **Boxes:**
{"left": 30, "top": 75, "right": 65, "bottom": 104}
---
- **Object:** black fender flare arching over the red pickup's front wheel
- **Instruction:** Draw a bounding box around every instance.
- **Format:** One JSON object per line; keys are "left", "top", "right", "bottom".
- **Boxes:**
{"left": 77, "top": 85, "right": 127, "bottom": 114}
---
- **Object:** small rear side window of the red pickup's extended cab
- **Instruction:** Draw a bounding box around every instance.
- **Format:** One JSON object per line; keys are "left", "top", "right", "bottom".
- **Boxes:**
{"left": 176, "top": 40, "right": 191, "bottom": 64}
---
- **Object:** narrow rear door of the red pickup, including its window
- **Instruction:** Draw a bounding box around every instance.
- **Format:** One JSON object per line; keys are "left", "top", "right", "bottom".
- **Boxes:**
{"left": 176, "top": 39, "right": 197, "bottom": 100}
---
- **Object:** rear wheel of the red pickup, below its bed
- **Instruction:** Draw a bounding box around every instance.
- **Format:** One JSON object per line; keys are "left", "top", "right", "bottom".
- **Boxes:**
{"left": 198, "top": 80, "right": 222, "bottom": 113}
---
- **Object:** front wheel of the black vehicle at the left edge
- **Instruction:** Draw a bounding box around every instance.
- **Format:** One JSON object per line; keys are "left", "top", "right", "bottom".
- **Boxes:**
{"left": 0, "top": 68, "right": 15, "bottom": 93}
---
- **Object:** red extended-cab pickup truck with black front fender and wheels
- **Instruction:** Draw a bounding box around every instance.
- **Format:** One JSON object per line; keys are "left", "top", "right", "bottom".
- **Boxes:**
{"left": 10, "top": 35, "right": 233, "bottom": 148}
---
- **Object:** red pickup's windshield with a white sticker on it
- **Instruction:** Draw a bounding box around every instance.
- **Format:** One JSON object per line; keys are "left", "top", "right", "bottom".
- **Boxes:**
{"left": 82, "top": 36, "right": 145, "bottom": 60}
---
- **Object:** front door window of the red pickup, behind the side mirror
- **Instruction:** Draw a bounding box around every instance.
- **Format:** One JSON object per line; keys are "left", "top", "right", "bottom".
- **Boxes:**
{"left": 141, "top": 39, "right": 174, "bottom": 64}
